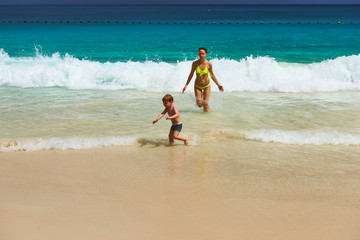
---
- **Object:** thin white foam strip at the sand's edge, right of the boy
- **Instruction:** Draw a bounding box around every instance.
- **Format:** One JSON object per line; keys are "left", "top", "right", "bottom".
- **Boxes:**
{"left": 241, "top": 129, "right": 360, "bottom": 146}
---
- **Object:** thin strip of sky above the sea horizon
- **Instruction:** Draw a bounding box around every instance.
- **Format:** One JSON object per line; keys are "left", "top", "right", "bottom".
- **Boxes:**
{"left": 0, "top": 0, "right": 360, "bottom": 5}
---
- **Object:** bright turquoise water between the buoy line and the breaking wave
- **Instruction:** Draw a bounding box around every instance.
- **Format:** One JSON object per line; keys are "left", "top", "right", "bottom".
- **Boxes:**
{"left": 0, "top": 24, "right": 360, "bottom": 63}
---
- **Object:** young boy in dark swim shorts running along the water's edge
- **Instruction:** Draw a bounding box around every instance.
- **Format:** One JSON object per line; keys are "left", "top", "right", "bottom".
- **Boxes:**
{"left": 153, "top": 94, "right": 189, "bottom": 145}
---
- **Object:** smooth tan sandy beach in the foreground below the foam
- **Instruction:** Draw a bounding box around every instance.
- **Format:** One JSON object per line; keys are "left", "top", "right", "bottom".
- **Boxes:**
{"left": 0, "top": 141, "right": 360, "bottom": 240}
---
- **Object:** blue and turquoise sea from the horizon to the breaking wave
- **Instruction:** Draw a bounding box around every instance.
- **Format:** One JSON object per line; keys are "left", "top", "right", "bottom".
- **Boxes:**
{"left": 0, "top": 5, "right": 360, "bottom": 63}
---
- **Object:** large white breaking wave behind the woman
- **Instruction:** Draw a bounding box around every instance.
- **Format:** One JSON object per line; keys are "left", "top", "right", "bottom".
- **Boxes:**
{"left": 0, "top": 50, "right": 360, "bottom": 92}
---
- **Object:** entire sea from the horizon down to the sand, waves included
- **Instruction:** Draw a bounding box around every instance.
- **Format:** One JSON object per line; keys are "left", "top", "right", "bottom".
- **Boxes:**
{"left": 0, "top": 6, "right": 360, "bottom": 151}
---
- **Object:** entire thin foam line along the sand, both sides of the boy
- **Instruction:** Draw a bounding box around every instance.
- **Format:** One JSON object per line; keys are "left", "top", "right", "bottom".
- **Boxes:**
{"left": 0, "top": 129, "right": 360, "bottom": 152}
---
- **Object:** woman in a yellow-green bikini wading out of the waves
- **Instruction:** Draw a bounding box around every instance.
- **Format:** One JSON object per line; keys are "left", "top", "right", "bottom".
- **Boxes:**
{"left": 183, "top": 48, "right": 224, "bottom": 112}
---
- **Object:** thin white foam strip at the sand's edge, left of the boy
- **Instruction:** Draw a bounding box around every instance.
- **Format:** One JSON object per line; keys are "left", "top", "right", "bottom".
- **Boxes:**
{"left": 0, "top": 136, "right": 137, "bottom": 152}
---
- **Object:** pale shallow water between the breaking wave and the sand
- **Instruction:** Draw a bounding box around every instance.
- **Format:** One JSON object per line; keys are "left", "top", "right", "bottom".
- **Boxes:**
{"left": 0, "top": 87, "right": 360, "bottom": 150}
